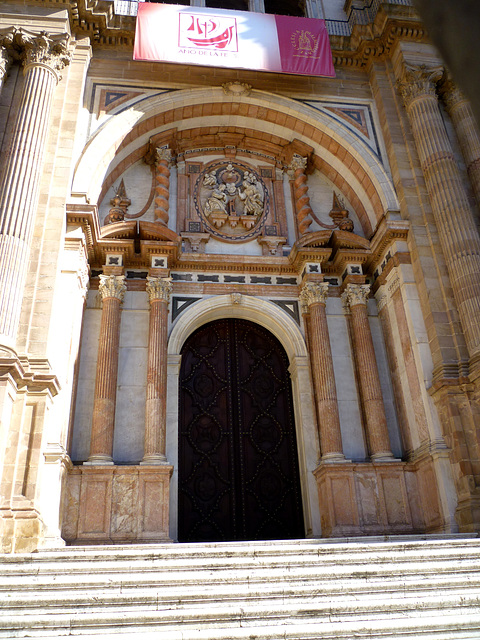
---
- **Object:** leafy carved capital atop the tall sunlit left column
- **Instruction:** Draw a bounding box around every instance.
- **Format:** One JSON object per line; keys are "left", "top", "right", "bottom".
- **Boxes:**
{"left": 17, "top": 30, "right": 71, "bottom": 81}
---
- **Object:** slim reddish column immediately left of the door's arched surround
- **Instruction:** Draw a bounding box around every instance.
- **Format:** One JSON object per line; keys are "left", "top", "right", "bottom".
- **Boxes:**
{"left": 141, "top": 277, "right": 172, "bottom": 464}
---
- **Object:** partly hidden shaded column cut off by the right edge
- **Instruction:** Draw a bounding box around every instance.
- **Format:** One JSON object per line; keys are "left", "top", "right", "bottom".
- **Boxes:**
{"left": 440, "top": 78, "right": 480, "bottom": 207}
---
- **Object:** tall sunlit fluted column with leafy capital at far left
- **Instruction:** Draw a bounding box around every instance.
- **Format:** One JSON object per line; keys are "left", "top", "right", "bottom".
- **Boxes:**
{"left": 0, "top": 30, "right": 70, "bottom": 346}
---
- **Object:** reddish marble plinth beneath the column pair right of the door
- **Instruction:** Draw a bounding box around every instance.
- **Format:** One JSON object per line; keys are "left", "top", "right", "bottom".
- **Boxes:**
{"left": 314, "top": 462, "right": 441, "bottom": 538}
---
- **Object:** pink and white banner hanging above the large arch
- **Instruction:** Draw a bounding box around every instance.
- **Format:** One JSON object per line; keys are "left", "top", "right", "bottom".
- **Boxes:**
{"left": 133, "top": 3, "right": 335, "bottom": 77}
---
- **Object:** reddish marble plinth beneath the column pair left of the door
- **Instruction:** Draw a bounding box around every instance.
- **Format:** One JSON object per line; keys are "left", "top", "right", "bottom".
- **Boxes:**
{"left": 62, "top": 465, "right": 173, "bottom": 544}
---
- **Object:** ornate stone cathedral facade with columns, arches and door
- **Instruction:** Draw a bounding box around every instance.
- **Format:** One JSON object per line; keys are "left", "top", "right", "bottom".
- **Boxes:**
{"left": 0, "top": 0, "right": 480, "bottom": 553}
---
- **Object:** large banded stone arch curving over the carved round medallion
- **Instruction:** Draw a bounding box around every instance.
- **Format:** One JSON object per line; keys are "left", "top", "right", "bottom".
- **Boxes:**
{"left": 72, "top": 88, "right": 398, "bottom": 237}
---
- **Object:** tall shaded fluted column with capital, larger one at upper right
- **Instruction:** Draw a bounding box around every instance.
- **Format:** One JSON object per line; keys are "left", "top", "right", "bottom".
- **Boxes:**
{"left": 399, "top": 65, "right": 480, "bottom": 369}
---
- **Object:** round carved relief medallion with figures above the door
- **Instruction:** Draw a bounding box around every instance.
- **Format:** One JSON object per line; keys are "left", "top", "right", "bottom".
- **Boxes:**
{"left": 194, "top": 162, "right": 268, "bottom": 240}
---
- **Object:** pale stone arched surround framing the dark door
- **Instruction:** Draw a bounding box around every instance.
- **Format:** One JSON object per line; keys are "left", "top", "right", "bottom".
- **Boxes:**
{"left": 167, "top": 293, "right": 321, "bottom": 538}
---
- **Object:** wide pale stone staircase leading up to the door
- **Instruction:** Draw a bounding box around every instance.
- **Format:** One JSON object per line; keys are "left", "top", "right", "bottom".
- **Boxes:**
{"left": 0, "top": 536, "right": 480, "bottom": 640}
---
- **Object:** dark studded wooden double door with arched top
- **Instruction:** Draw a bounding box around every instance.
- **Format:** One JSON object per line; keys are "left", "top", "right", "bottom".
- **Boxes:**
{"left": 178, "top": 318, "right": 304, "bottom": 542}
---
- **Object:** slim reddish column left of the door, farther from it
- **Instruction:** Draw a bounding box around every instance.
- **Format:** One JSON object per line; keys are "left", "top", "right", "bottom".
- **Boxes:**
{"left": 88, "top": 275, "right": 126, "bottom": 464}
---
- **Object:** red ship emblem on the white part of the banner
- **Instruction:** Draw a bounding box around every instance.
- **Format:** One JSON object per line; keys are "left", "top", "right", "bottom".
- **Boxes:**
{"left": 178, "top": 13, "right": 238, "bottom": 53}
